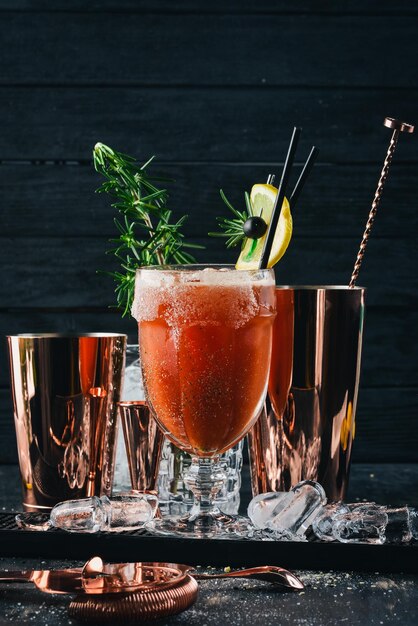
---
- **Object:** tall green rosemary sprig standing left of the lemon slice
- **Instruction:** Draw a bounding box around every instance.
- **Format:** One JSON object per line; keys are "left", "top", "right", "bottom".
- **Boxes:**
{"left": 93, "top": 143, "right": 203, "bottom": 316}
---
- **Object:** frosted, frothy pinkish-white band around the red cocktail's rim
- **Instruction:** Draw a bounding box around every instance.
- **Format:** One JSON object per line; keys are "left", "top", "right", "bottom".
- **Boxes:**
{"left": 132, "top": 268, "right": 273, "bottom": 328}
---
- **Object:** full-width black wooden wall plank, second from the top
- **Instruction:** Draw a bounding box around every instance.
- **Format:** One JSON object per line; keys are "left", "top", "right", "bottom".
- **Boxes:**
{"left": 0, "top": 13, "right": 418, "bottom": 88}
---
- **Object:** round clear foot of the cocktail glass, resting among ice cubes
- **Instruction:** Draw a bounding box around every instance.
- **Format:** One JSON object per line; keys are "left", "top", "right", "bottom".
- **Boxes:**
{"left": 146, "top": 513, "right": 254, "bottom": 539}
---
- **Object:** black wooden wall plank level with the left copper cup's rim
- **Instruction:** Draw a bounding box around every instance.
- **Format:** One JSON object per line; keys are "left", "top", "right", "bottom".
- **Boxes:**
{"left": 0, "top": 304, "right": 418, "bottom": 387}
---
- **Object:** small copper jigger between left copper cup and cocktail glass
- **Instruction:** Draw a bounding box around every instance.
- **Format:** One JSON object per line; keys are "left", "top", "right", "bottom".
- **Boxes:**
{"left": 119, "top": 401, "right": 164, "bottom": 491}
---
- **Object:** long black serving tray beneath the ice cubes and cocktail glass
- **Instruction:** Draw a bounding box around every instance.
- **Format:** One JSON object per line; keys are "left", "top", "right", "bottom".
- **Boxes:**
{"left": 0, "top": 512, "right": 418, "bottom": 574}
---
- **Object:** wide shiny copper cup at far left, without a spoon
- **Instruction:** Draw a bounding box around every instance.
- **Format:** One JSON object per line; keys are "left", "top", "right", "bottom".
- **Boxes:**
{"left": 8, "top": 333, "right": 126, "bottom": 510}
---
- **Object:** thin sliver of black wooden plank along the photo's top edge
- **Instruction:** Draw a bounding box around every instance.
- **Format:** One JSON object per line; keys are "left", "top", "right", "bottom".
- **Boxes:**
{"left": 0, "top": 0, "right": 417, "bottom": 15}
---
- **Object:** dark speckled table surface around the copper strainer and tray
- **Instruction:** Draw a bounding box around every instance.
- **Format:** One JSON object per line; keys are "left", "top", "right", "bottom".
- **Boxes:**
{"left": 0, "top": 464, "right": 418, "bottom": 626}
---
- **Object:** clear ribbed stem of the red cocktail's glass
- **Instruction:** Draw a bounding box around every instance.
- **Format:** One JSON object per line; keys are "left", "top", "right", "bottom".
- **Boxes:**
{"left": 184, "top": 456, "right": 227, "bottom": 521}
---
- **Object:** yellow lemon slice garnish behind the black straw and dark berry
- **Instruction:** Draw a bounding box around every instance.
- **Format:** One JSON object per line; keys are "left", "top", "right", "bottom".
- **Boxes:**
{"left": 235, "top": 184, "right": 293, "bottom": 270}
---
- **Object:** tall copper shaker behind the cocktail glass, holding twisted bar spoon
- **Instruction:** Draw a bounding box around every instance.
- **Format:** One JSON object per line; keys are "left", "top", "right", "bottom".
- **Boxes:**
{"left": 249, "top": 287, "right": 365, "bottom": 500}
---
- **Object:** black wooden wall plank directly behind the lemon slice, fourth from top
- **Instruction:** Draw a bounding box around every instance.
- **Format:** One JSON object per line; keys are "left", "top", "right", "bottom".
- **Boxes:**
{"left": 0, "top": 161, "right": 418, "bottom": 239}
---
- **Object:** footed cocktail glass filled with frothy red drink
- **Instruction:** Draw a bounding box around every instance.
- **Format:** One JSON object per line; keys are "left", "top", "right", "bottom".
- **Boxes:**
{"left": 132, "top": 265, "right": 276, "bottom": 537}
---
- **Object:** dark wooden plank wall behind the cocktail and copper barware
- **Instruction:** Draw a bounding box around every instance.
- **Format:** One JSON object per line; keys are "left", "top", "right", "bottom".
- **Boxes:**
{"left": 0, "top": 0, "right": 418, "bottom": 462}
